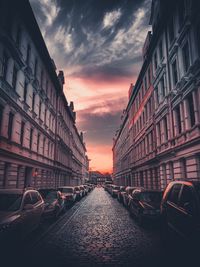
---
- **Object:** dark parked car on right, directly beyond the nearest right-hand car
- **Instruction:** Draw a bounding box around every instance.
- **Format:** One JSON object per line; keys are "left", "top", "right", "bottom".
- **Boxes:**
{"left": 129, "top": 189, "right": 162, "bottom": 224}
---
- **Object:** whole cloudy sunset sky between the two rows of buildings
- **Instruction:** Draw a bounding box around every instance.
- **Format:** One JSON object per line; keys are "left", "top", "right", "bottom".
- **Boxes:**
{"left": 30, "top": 0, "right": 151, "bottom": 172}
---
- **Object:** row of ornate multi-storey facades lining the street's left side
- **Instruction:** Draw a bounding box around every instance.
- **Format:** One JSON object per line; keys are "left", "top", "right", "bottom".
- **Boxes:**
{"left": 0, "top": 0, "right": 89, "bottom": 188}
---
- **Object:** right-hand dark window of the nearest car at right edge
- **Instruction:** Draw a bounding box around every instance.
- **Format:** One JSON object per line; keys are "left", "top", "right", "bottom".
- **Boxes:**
{"left": 179, "top": 185, "right": 194, "bottom": 216}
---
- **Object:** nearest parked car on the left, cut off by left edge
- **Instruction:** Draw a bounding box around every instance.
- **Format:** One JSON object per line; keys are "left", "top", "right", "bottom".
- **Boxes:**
{"left": 0, "top": 189, "right": 44, "bottom": 242}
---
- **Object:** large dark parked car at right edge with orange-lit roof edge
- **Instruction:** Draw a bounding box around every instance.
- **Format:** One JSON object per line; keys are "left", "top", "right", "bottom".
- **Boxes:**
{"left": 161, "top": 181, "right": 200, "bottom": 245}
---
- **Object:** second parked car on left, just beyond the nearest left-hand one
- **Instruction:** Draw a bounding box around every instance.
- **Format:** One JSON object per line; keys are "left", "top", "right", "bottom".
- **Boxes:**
{"left": 38, "top": 188, "right": 65, "bottom": 219}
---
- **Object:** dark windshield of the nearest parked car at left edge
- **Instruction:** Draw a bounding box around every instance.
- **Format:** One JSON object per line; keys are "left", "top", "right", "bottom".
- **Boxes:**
{"left": 0, "top": 194, "right": 23, "bottom": 211}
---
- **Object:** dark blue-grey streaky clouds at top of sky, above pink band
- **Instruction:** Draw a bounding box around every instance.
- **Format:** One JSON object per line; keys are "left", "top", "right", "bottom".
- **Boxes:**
{"left": 31, "top": 0, "right": 150, "bottom": 77}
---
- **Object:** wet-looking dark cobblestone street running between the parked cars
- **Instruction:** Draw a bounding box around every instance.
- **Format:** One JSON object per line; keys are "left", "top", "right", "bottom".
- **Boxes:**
{"left": 23, "top": 188, "right": 162, "bottom": 266}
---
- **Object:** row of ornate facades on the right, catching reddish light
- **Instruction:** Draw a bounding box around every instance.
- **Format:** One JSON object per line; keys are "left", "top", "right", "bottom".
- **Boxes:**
{"left": 113, "top": 0, "right": 200, "bottom": 190}
